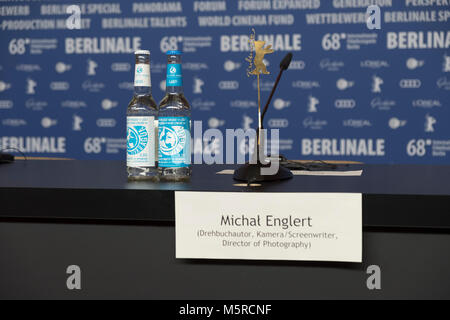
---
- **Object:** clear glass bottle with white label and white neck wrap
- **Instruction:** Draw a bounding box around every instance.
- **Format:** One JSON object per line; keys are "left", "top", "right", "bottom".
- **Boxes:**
{"left": 127, "top": 50, "right": 158, "bottom": 181}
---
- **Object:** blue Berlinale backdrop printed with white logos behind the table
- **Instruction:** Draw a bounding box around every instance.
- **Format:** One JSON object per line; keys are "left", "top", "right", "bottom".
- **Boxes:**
{"left": 0, "top": 0, "right": 450, "bottom": 163}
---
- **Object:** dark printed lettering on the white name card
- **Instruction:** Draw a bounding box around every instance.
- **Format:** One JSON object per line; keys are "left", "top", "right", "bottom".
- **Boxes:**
{"left": 197, "top": 215, "right": 338, "bottom": 250}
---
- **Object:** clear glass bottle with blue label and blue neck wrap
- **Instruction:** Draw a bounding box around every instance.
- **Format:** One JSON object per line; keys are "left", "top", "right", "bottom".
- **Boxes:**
{"left": 158, "top": 51, "right": 191, "bottom": 181}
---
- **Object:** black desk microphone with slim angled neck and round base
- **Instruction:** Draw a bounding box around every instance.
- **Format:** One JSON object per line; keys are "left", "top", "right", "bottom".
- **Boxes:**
{"left": 233, "top": 53, "right": 293, "bottom": 184}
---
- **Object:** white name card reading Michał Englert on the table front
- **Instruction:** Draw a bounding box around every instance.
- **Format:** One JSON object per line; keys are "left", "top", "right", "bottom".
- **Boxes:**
{"left": 175, "top": 191, "right": 362, "bottom": 263}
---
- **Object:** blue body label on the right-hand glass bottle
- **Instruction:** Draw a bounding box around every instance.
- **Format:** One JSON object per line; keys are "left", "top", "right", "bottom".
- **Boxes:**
{"left": 158, "top": 117, "right": 191, "bottom": 168}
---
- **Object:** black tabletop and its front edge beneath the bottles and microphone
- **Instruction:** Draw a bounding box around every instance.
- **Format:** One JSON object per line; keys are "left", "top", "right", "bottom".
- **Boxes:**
{"left": 0, "top": 160, "right": 450, "bottom": 229}
